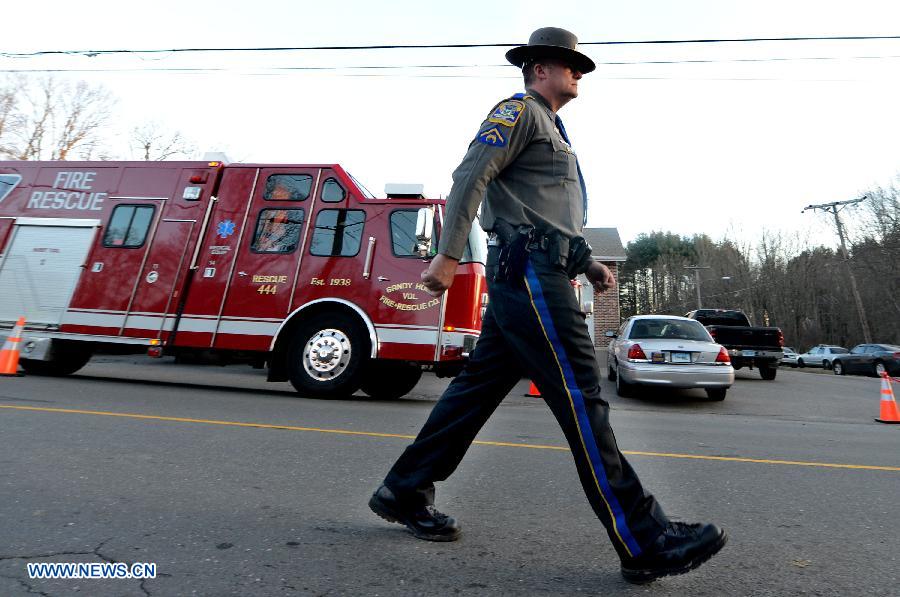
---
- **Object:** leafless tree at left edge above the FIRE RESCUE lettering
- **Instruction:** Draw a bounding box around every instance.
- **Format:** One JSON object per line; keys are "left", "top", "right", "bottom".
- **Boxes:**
{"left": 0, "top": 77, "right": 115, "bottom": 160}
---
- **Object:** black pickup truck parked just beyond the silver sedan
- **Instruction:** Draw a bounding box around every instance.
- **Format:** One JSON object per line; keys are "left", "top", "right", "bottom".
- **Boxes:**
{"left": 685, "top": 309, "right": 784, "bottom": 379}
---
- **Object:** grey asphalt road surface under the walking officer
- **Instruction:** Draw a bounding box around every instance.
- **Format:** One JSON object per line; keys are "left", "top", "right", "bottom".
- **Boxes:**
{"left": 0, "top": 357, "right": 900, "bottom": 596}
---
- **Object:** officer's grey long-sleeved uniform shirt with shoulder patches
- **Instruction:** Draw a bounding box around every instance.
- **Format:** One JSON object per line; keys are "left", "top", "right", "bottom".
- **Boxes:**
{"left": 438, "top": 90, "right": 584, "bottom": 259}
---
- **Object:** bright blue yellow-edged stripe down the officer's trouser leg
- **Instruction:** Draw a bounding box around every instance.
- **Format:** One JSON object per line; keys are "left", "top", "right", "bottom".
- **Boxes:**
{"left": 525, "top": 260, "right": 641, "bottom": 557}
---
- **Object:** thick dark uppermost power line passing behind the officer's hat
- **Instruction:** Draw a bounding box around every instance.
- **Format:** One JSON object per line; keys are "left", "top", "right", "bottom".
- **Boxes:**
{"left": 0, "top": 35, "right": 900, "bottom": 58}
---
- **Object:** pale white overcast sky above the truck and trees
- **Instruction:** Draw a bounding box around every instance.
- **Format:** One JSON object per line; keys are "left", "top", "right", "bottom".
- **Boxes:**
{"left": 0, "top": 0, "right": 900, "bottom": 248}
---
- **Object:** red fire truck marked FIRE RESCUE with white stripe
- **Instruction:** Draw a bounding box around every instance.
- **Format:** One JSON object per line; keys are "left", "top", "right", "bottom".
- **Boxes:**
{"left": 0, "top": 162, "right": 487, "bottom": 397}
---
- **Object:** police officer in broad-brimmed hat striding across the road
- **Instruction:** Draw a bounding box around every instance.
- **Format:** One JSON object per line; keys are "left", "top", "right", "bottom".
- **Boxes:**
{"left": 369, "top": 27, "right": 726, "bottom": 583}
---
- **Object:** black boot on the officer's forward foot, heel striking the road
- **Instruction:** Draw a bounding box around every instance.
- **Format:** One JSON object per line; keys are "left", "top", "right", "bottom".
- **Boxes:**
{"left": 622, "top": 522, "right": 728, "bottom": 584}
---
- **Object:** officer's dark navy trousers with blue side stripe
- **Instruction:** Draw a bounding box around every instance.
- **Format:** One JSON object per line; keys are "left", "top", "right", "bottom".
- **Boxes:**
{"left": 385, "top": 247, "right": 667, "bottom": 558}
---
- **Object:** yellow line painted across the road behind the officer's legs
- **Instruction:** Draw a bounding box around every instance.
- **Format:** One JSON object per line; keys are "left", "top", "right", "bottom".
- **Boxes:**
{"left": 0, "top": 405, "right": 900, "bottom": 472}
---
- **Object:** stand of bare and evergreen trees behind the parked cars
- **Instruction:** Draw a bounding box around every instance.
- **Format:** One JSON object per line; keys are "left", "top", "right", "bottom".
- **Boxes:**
{"left": 620, "top": 206, "right": 900, "bottom": 350}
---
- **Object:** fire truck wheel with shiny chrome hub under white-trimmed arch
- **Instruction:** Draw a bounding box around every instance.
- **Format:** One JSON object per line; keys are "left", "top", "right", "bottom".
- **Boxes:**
{"left": 288, "top": 313, "right": 368, "bottom": 398}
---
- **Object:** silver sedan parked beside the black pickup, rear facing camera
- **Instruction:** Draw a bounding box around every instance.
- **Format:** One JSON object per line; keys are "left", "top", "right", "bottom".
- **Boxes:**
{"left": 606, "top": 315, "right": 734, "bottom": 400}
